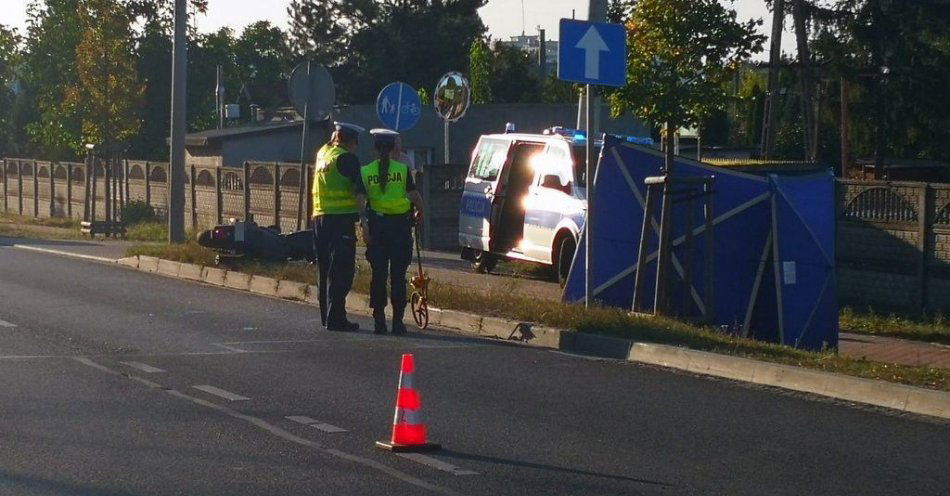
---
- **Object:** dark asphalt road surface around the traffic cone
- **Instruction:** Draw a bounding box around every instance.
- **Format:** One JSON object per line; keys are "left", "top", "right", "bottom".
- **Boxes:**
{"left": 0, "top": 247, "right": 950, "bottom": 496}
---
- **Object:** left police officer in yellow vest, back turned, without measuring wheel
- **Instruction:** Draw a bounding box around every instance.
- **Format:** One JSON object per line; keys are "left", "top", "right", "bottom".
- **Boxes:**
{"left": 313, "top": 122, "right": 365, "bottom": 331}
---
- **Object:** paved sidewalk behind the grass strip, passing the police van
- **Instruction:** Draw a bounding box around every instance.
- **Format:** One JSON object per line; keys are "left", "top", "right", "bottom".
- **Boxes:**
{"left": 0, "top": 237, "right": 950, "bottom": 369}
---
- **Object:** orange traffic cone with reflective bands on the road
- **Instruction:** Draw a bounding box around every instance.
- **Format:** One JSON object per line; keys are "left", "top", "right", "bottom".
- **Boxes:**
{"left": 376, "top": 353, "right": 441, "bottom": 453}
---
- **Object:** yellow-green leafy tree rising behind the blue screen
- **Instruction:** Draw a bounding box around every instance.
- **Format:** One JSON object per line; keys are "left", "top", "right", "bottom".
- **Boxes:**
{"left": 610, "top": 0, "right": 764, "bottom": 167}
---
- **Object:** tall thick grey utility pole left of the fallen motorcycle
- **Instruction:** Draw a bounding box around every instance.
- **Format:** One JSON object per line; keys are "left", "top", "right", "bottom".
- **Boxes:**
{"left": 168, "top": 0, "right": 188, "bottom": 243}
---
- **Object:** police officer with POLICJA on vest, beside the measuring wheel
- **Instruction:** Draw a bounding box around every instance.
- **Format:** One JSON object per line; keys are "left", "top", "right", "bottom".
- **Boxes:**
{"left": 359, "top": 129, "right": 424, "bottom": 334}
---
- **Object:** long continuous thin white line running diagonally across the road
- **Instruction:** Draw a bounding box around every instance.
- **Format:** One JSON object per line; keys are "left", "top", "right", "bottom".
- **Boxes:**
{"left": 76, "top": 358, "right": 460, "bottom": 496}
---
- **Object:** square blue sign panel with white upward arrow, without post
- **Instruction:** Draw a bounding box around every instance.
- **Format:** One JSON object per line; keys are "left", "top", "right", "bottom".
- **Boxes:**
{"left": 557, "top": 19, "right": 627, "bottom": 86}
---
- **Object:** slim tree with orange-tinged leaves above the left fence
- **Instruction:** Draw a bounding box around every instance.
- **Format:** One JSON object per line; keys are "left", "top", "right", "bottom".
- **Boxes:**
{"left": 62, "top": 0, "right": 145, "bottom": 154}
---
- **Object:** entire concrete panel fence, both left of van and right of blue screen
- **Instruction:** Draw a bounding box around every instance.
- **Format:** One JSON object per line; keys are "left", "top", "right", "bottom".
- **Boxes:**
{"left": 0, "top": 158, "right": 950, "bottom": 311}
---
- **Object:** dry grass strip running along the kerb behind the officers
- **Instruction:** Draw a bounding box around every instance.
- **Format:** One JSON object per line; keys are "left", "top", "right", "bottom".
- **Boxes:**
{"left": 128, "top": 242, "right": 950, "bottom": 391}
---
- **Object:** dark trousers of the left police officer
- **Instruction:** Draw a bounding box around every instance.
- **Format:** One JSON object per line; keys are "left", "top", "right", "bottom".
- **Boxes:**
{"left": 313, "top": 214, "right": 358, "bottom": 327}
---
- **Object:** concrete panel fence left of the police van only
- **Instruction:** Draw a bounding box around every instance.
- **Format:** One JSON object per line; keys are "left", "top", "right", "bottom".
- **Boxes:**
{"left": 0, "top": 158, "right": 467, "bottom": 249}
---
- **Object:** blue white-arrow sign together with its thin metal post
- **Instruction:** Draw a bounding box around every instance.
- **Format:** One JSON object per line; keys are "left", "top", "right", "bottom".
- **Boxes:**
{"left": 557, "top": 19, "right": 627, "bottom": 307}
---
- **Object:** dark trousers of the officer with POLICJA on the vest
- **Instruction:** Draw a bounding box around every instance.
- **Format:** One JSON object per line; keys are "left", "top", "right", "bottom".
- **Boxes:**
{"left": 366, "top": 212, "right": 412, "bottom": 316}
